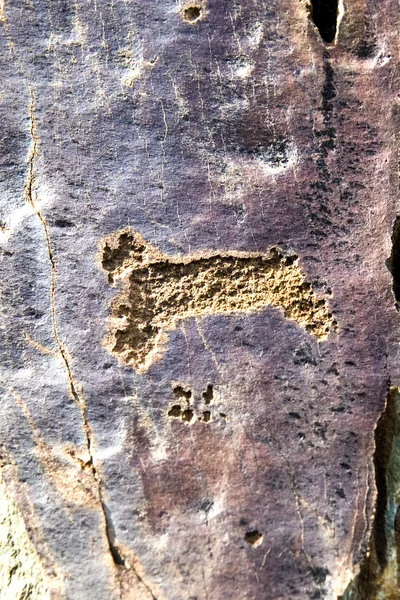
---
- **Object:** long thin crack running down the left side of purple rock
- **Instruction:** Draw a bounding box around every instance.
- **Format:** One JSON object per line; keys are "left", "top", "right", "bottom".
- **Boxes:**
{"left": 24, "top": 89, "right": 157, "bottom": 600}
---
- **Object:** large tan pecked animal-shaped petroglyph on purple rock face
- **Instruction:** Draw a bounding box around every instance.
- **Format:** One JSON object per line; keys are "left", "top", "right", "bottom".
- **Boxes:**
{"left": 101, "top": 228, "right": 337, "bottom": 372}
